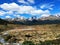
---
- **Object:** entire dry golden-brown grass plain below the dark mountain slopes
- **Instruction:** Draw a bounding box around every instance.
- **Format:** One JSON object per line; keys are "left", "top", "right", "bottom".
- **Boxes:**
{"left": 0, "top": 24, "right": 60, "bottom": 43}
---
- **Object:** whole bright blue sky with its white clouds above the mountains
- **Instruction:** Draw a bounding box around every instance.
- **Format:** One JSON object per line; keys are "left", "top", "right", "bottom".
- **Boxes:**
{"left": 0, "top": 0, "right": 60, "bottom": 18}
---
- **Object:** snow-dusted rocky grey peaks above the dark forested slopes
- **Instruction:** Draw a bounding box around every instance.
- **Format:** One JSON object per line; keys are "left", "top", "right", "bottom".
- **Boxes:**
{"left": 5, "top": 15, "right": 60, "bottom": 22}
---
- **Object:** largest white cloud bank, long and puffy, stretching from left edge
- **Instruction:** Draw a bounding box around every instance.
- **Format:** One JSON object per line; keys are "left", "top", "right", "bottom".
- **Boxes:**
{"left": 0, "top": 3, "right": 50, "bottom": 15}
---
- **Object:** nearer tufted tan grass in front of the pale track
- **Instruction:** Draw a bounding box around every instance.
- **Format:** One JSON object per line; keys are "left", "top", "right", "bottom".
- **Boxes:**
{"left": 2, "top": 30, "right": 60, "bottom": 43}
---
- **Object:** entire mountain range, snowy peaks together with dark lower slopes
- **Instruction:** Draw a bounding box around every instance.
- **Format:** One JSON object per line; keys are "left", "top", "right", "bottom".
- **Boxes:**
{"left": 0, "top": 15, "right": 60, "bottom": 25}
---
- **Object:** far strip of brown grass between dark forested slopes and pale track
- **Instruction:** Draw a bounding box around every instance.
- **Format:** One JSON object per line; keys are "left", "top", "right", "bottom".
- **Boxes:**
{"left": 0, "top": 24, "right": 60, "bottom": 30}
